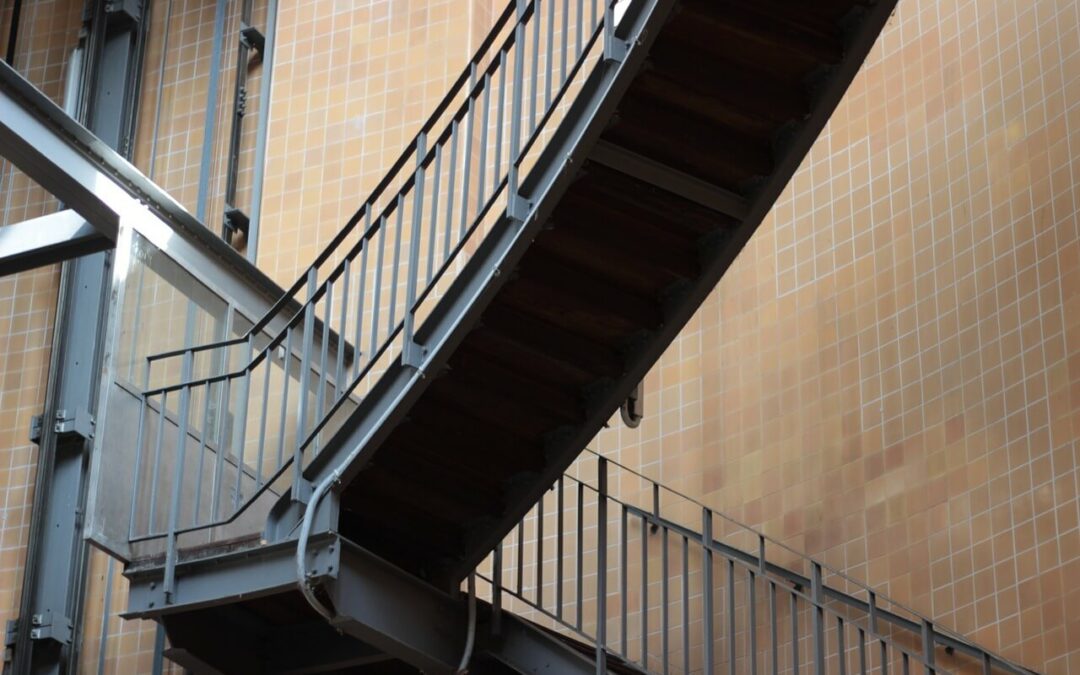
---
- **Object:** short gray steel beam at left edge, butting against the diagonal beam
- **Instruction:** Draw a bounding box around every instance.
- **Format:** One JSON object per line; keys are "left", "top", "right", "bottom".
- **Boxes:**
{"left": 0, "top": 208, "right": 116, "bottom": 276}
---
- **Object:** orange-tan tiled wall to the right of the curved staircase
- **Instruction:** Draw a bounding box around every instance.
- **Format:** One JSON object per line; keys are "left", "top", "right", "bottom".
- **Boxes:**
{"left": 596, "top": 0, "right": 1080, "bottom": 674}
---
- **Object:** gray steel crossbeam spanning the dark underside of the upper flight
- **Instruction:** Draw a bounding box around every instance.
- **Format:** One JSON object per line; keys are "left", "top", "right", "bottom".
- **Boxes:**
{"left": 589, "top": 140, "right": 750, "bottom": 220}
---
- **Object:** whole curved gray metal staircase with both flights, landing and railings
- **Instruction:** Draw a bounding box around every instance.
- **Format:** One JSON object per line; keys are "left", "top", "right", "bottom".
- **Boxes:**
{"left": 56, "top": 0, "right": 1026, "bottom": 673}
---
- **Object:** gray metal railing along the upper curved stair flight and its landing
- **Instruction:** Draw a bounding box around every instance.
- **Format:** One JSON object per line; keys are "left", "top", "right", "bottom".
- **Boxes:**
{"left": 129, "top": 0, "right": 630, "bottom": 597}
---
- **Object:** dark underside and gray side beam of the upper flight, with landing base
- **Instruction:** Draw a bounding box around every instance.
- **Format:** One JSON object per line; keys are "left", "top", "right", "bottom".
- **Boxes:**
{"left": 116, "top": 0, "right": 946, "bottom": 673}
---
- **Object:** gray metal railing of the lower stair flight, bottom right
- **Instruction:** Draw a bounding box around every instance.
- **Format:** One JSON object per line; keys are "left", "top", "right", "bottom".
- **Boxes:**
{"left": 476, "top": 450, "right": 1032, "bottom": 675}
